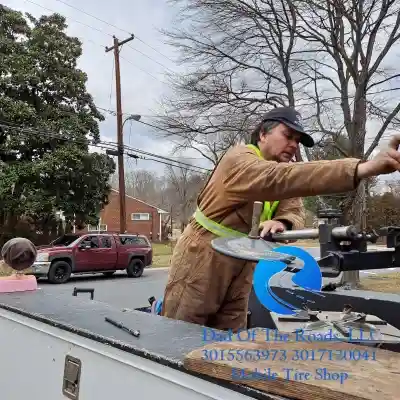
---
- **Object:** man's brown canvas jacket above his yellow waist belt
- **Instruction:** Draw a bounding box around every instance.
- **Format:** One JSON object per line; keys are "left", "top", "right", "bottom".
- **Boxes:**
{"left": 191, "top": 145, "right": 360, "bottom": 233}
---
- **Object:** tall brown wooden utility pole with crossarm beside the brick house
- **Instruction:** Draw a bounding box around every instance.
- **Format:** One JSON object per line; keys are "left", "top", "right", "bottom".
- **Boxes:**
{"left": 106, "top": 35, "right": 134, "bottom": 233}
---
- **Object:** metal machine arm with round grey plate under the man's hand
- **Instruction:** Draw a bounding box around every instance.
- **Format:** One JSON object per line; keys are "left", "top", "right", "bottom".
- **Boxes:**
{"left": 211, "top": 202, "right": 400, "bottom": 277}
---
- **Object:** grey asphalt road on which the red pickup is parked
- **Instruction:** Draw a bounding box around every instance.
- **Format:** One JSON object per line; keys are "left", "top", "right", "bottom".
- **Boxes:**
{"left": 39, "top": 248, "right": 399, "bottom": 309}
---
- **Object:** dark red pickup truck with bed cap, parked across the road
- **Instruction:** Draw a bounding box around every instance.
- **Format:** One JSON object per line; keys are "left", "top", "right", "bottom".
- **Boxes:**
{"left": 32, "top": 233, "right": 153, "bottom": 283}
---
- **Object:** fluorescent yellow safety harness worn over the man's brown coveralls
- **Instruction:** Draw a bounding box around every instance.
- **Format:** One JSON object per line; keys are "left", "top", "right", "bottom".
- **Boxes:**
{"left": 193, "top": 144, "right": 279, "bottom": 237}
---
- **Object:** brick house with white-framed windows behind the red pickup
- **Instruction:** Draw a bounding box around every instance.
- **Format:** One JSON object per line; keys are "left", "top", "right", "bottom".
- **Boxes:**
{"left": 75, "top": 189, "right": 168, "bottom": 241}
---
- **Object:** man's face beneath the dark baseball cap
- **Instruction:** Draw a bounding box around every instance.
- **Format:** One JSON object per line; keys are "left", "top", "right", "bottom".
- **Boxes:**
{"left": 259, "top": 124, "right": 301, "bottom": 162}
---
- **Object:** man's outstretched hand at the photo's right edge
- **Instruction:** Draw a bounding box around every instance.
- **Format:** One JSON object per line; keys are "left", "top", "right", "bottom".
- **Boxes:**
{"left": 357, "top": 134, "right": 400, "bottom": 179}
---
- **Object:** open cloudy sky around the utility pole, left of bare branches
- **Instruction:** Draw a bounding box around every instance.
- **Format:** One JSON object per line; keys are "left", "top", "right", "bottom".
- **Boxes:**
{"left": 2, "top": 0, "right": 209, "bottom": 177}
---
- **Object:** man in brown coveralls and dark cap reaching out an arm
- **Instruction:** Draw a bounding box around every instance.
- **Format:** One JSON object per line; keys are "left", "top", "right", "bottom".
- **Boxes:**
{"left": 161, "top": 107, "right": 400, "bottom": 332}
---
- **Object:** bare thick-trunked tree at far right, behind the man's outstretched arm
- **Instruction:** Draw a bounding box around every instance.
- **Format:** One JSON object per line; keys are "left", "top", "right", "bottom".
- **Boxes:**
{"left": 288, "top": 0, "right": 400, "bottom": 231}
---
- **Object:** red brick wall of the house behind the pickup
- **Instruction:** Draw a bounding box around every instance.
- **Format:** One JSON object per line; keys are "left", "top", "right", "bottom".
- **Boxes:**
{"left": 76, "top": 191, "right": 161, "bottom": 241}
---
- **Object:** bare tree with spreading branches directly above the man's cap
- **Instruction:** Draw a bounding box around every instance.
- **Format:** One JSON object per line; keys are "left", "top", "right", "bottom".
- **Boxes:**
{"left": 153, "top": 0, "right": 309, "bottom": 164}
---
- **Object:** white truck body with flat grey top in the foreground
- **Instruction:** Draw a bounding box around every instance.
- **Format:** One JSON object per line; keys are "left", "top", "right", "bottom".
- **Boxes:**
{"left": 0, "top": 290, "right": 287, "bottom": 400}
